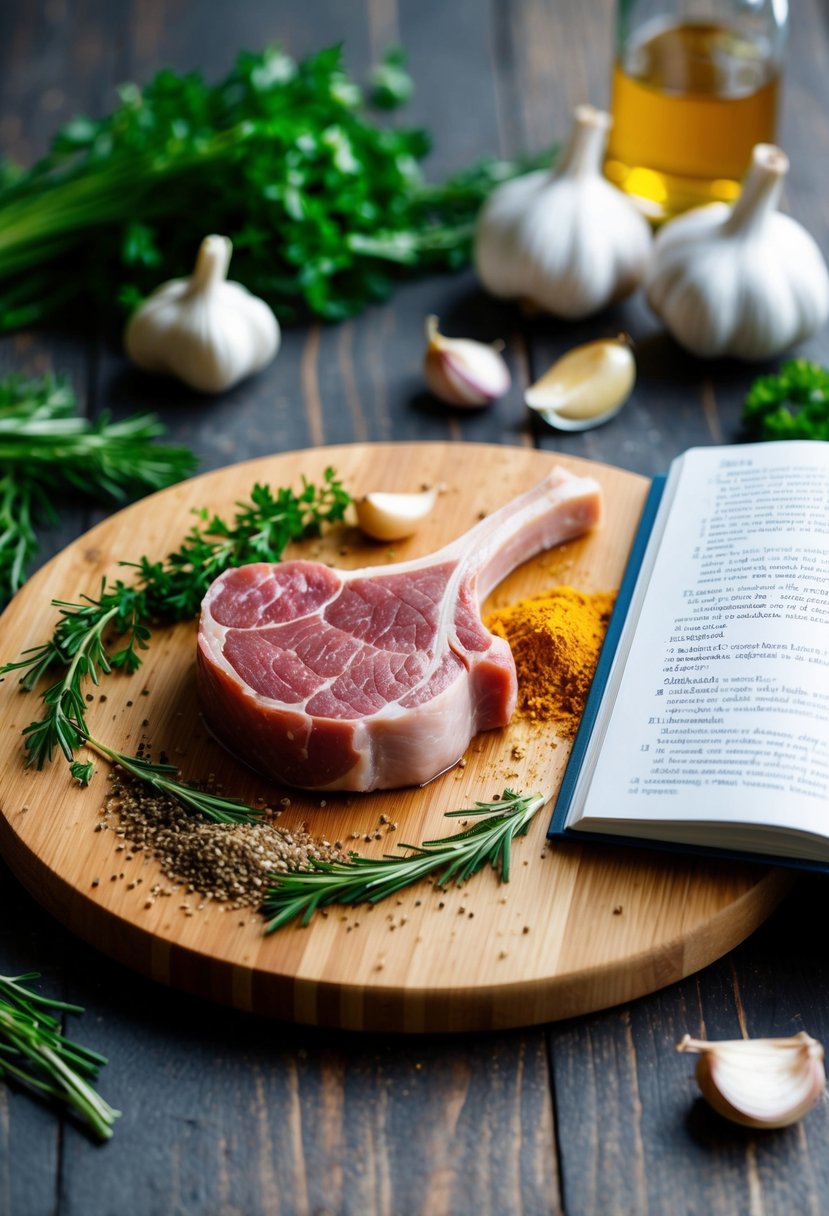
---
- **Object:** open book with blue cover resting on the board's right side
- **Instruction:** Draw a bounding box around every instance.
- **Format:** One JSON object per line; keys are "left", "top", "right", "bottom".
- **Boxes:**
{"left": 549, "top": 441, "right": 829, "bottom": 869}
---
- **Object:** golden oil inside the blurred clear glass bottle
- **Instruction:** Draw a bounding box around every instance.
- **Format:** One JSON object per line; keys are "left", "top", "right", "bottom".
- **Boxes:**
{"left": 605, "top": 24, "right": 779, "bottom": 219}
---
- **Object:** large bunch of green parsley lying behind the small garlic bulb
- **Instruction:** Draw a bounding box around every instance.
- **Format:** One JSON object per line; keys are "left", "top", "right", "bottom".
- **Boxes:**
{"left": 0, "top": 46, "right": 549, "bottom": 332}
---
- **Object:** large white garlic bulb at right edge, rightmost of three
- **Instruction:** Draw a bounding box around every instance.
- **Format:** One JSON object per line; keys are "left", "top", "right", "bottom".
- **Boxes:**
{"left": 645, "top": 143, "right": 829, "bottom": 359}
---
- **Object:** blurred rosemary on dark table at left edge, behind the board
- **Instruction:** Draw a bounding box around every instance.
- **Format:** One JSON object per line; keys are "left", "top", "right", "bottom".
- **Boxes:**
{"left": 0, "top": 376, "right": 196, "bottom": 607}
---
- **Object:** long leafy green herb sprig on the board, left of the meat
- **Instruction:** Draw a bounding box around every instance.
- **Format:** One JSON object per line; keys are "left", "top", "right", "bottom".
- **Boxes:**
{"left": 0, "top": 468, "right": 351, "bottom": 769}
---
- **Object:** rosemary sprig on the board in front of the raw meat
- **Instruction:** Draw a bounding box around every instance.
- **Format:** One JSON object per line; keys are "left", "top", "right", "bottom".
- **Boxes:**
{"left": 261, "top": 789, "right": 547, "bottom": 933}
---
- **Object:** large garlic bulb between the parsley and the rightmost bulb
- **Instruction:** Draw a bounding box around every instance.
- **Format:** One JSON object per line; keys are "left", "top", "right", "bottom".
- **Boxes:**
{"left": 475, "top": 106, "right": 653, "bottom": 319}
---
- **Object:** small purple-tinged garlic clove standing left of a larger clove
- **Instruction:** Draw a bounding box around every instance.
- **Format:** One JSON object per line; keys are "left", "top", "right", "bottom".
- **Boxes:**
{"left": 423, "top": 316, "right": 511, "bottom": 406}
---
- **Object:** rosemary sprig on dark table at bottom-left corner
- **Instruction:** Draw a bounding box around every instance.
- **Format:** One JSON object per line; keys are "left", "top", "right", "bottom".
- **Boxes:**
{"left": 0, "top": 972, "right": 120, "bottom": 1139}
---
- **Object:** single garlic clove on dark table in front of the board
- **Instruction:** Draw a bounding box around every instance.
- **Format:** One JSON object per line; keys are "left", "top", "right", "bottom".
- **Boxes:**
{"left": 676, "top": 1030, "right": 827, "bottom": 1128}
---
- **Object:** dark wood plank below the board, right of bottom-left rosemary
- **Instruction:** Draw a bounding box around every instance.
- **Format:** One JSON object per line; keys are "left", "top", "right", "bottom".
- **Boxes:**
{"left": 55, "top": 929, "right": 558, "bottom": 1216}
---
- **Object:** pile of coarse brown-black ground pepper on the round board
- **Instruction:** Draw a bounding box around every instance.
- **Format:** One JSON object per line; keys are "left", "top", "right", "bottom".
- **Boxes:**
{"left": 102, "top": 770, "right": 349, "bottom": 908}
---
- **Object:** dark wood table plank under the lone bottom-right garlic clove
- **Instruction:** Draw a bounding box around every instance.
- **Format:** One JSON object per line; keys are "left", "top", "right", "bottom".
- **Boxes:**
{"left": 549, "top": 879, "right": 829, "bottom": 1216}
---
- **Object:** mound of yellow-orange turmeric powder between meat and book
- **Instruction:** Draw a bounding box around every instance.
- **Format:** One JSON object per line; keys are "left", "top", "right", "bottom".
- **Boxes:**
{"left": 486, "top": 587, "right": 615, "bottom": 738}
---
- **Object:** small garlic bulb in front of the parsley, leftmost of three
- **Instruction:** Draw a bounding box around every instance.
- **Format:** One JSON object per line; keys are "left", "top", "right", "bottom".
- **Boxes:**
{"left": 124, "top": 236, "right": 280, "bottom": 393}
